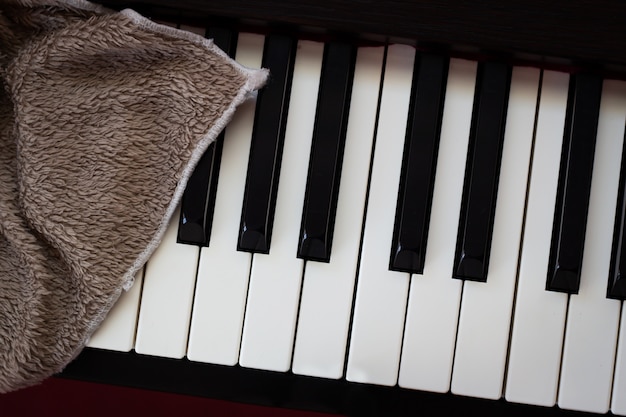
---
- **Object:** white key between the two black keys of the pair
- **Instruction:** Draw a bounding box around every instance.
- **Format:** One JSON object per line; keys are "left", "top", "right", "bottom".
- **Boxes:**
{"left": 398, "top": 59, "right": 477, "bottom": 392}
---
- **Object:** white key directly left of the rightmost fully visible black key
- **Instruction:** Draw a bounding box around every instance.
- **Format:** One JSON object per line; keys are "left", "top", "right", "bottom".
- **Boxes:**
{"left": 505, "top": 71, "right": 569, "bottom": 406}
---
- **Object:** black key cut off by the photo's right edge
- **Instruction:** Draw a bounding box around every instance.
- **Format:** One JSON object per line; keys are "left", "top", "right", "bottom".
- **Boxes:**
{"left": 607, "top": 132, "right": 626, "bottom": 300}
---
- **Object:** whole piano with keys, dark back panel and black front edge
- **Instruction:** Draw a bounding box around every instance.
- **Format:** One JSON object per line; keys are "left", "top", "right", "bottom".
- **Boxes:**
{"left": 60, "top": 0, "right": 626, "bottom": 416}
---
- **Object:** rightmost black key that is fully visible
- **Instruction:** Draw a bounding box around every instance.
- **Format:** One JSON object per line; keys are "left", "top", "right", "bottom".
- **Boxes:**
{"left": 546, "top": 74, "right": 602, "bottom": 294}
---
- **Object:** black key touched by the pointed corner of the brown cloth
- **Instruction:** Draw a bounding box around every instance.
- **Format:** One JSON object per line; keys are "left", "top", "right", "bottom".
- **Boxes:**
{"left": 237, "top": 35, "right": 297, "bottom": 253}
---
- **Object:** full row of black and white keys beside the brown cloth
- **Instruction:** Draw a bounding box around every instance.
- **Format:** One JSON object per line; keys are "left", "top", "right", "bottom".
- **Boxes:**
{"left": 81, "top": 21, "right": 626, "bottom": 415}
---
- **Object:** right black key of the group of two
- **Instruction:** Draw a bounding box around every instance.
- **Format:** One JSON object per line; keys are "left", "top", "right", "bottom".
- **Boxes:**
{"left": 453, "top": 62, "right": 511, "bottom": 282}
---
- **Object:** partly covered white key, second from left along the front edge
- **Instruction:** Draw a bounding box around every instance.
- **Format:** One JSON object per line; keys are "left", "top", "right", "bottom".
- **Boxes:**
{"left": 135, "top": 209, "right": 200, "bottom": 359}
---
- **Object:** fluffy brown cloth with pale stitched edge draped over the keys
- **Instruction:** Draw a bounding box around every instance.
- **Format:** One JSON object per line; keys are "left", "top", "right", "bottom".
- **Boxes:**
{"left": 0, "top": 0, "right": 267, "bottom": 392}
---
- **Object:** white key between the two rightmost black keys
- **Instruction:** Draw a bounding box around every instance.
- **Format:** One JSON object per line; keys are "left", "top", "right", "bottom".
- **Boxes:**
{"left": 558, "top": 81, "right": 626, "bottom": 413}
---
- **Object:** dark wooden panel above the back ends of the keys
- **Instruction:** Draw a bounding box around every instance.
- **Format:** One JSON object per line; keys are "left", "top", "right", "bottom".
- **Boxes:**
{"left": 103, "top": 0, "right": 626, "bottom": 73}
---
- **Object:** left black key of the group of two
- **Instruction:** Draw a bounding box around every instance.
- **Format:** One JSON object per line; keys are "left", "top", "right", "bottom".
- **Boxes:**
{"left": 389, "top": 54, "right": 449, "bottom": 274}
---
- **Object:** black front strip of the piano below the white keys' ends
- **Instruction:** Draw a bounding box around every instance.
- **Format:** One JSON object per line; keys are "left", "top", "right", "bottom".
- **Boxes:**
{"left": 56, "top": 348, "right": 610, "bottom": 417}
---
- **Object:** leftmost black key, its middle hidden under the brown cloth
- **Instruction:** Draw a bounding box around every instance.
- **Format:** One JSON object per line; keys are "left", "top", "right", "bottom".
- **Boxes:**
{"left": 178, "top": 28, "right": 237, "bottom": 246}
